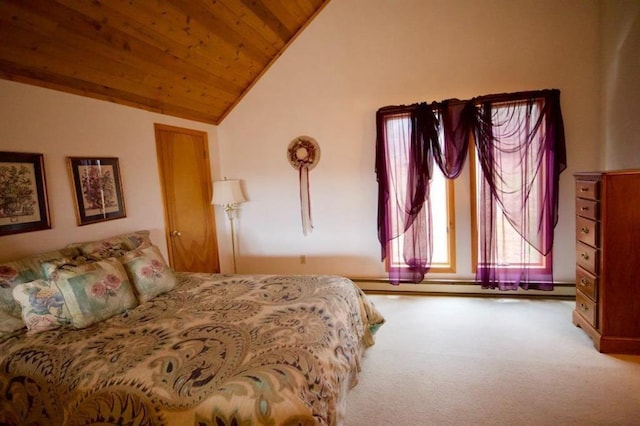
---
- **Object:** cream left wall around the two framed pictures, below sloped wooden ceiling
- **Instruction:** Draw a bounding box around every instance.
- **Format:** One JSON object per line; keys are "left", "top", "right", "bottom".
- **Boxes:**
{"left": 0, "top": 80, "right": 218, "bottom": 261}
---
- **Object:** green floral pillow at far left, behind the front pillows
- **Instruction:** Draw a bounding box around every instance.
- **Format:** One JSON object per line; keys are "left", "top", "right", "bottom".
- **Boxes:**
{"left": 0, "top": 248, "right": 80, "bottom": 319}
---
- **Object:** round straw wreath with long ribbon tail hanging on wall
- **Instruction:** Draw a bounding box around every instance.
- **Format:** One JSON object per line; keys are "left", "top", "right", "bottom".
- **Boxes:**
{"left": 287, "top": 136, "right": 320, "bottom": 236}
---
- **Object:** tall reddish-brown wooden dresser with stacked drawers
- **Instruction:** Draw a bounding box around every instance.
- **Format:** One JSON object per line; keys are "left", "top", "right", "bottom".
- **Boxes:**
{"left": 573, "top": 170, "right": 640, "bottom": 354}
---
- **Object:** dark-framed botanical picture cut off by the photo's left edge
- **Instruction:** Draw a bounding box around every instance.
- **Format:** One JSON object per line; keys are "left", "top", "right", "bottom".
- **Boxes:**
{"left": 0, "top": 151, "right": 51, "bottom": 236}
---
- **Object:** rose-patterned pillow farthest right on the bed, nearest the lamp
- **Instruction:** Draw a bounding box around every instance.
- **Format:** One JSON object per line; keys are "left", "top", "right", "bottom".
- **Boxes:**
{"left": 120, "top": 245, "right": 176, "bottom": 303}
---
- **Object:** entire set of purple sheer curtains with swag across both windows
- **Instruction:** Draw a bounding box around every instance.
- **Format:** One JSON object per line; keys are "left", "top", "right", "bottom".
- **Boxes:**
{"left": 376, "top": 89, "right": 566, "bottom": 290}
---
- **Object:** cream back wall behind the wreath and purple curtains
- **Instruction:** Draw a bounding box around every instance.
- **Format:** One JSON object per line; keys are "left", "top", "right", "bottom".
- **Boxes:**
{"left": 218, "top": 0, "right": 600, "bottom": 280}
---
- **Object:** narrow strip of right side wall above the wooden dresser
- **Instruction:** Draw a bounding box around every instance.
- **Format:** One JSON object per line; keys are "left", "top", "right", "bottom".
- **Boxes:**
{"left": 600, "top": 0, "right": 640, "bottom": 169}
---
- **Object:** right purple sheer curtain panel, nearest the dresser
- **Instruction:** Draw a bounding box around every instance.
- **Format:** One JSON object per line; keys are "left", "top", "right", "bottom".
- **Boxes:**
{"left": 475, "top": 91, "right": 566, "bottom": 290}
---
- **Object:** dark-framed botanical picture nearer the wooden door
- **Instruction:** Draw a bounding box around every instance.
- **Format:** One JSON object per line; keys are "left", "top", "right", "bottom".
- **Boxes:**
{"left": 67, "top": 157, "right": 126, "bottom": 226}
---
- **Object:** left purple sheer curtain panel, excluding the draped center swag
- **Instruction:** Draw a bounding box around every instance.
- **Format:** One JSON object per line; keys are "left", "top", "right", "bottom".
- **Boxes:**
{"left": 376, "top": 104, "right": 438, "bottom": 284}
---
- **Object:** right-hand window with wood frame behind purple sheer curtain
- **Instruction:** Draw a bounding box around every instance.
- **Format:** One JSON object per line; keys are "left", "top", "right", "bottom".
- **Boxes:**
{"left": 470, "top": 98, "right": 551, "bottom": 282}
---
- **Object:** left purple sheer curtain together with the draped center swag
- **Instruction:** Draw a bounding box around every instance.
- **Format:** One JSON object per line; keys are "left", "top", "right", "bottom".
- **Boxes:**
{"left": 376, "top": 100, "right": 475, "bottom": 284}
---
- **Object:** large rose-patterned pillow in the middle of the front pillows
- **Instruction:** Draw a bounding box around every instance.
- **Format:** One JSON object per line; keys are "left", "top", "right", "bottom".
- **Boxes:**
{"left": 52, "top": 258, "right": 138, "bottom": 328}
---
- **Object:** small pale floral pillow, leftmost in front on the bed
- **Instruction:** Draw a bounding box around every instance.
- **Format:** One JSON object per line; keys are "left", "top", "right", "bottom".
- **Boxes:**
{"left": 13, "top": 279, "right": 71, "bottom": 334}
